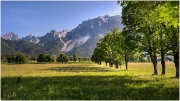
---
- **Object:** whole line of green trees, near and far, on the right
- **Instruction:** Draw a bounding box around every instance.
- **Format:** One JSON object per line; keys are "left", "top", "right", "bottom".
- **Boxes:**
{"left": 91, "top": 1, "right": 179, "bottom": 78}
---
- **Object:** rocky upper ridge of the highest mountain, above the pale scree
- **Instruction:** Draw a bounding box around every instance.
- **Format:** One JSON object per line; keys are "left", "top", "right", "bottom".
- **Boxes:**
{"left": 67, "top": 15, "right": 123, "bottom": 39}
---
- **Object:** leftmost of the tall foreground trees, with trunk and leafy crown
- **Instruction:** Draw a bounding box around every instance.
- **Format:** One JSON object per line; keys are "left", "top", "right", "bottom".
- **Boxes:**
{"left": 121, "top": 1, "right": 158, "bottom": 74}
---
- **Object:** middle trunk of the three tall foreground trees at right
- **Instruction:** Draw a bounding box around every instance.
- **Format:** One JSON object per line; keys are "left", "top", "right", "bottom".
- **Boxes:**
{"left": 161, "top": 48, "right": 166, "bottom": 75}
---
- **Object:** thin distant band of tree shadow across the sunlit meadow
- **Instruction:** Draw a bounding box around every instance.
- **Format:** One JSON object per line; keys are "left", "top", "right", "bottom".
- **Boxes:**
{"left": 43, "top": 66, "right": 115, "bottom": 72}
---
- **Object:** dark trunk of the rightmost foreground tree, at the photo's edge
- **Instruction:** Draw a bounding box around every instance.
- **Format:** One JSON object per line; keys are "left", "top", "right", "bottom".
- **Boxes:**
{"left": 173, "top": 50, "right": 179, "bottom": 78}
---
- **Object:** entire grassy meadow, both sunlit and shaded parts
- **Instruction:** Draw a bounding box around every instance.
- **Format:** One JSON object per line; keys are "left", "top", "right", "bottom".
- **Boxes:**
{"left": 1, "top": 62, "right": 179, "bottom": 100}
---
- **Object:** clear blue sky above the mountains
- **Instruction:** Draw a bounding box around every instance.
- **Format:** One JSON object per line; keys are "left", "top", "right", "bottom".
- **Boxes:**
{"left": 1, "top": 1, "right": 121, "bottom": 37}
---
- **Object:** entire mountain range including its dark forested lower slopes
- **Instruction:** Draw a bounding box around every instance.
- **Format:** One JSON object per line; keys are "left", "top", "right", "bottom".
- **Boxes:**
{"left": 1, "top": 15, "right": 124, "bottom": 57}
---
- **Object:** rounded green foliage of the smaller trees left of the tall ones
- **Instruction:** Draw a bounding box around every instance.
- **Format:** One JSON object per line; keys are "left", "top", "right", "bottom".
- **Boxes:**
{"left": 91, "top": 28, "right": 124, "bottom": 68}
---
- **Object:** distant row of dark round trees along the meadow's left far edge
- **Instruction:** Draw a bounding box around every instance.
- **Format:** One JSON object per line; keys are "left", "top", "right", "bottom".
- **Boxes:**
{"left": 1, "top": 53, "right": 89, "bottom": 64}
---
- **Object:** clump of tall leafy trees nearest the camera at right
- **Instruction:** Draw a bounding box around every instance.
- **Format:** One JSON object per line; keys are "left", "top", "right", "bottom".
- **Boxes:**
{"left": 119, "top": 1, "right": 179, "bottom": 77}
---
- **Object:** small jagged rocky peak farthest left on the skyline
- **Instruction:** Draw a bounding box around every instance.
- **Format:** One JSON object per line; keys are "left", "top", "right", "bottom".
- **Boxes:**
{"left": 1, "top": 32, "right": 19, "bottom": 40}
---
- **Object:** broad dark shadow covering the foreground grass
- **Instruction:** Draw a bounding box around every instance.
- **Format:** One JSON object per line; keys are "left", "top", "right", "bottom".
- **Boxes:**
{"left": 1, "top": 76, "right": 179, "bottom": 100}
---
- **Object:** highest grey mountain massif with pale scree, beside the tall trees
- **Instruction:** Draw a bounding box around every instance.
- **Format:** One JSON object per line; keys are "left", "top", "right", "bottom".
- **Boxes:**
{"left": 65, "top": 15, "right": 124, "bottom": 57}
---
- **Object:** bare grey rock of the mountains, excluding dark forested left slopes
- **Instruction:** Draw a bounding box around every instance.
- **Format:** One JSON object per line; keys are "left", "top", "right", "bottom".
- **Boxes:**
{"left": 2, "top": 15, "right": 124, "bottom": 57}
